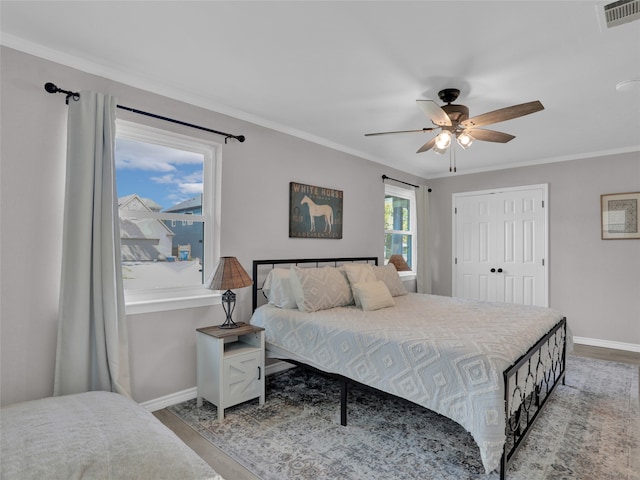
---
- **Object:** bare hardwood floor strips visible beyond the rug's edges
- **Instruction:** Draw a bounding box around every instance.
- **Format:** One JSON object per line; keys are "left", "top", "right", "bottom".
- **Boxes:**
{"left": 154, "top": 344, "right": 640, "bottom": 480}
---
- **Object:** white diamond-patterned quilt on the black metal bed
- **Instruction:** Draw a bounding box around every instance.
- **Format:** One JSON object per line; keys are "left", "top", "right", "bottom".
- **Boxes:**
{"left": 251, "top": 294, "right": 569, "bottom": 473}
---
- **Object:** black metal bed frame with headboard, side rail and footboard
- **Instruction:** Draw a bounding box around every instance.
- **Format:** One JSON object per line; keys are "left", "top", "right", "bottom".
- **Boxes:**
{"left": 252, "top": 257, "right": 567, "bottom": 480}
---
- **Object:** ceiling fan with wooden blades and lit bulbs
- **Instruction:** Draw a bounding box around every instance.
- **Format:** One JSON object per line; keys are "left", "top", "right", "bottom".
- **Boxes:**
{"left": 365, "top": 88, "right": 544, "bottom": 171}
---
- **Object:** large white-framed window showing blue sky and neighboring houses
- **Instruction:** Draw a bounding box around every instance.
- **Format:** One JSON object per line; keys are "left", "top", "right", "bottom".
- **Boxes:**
{"left": 115, "top": 120, "right": 220, "bottom": 313}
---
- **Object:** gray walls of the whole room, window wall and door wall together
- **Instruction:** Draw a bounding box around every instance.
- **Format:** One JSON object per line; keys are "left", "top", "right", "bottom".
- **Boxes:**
{"left": 0, "top": 47, "right": 640, "bottom": 405}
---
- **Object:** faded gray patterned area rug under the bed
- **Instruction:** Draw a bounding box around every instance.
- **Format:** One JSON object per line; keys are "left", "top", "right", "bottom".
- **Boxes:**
{"left": 169, "top": 356, "right": 640, "bottom": 480}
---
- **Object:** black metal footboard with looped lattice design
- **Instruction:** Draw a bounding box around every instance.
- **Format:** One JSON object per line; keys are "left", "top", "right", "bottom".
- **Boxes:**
{"left": 500, "top": 318, "right": 567, "bottom": 480}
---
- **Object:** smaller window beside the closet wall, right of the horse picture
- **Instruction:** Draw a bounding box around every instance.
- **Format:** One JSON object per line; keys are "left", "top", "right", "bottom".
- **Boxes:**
{"left": 384, "top": 185, "right": 417, "bottom": 269}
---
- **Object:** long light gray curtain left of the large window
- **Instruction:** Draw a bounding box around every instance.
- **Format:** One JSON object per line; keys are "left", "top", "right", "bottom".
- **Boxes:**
{"left": 53, "top": 92, "right": 131, "bottom": 396}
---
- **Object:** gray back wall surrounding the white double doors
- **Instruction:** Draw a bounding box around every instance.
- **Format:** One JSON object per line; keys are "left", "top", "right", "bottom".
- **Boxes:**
{"left": 429, "top": 153, "right": 640, "bottom": 347}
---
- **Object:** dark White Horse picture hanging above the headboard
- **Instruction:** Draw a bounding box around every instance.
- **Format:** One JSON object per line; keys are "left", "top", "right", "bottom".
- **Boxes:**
{"left": 289, "top": 182, "right": 343, "bottom": 239}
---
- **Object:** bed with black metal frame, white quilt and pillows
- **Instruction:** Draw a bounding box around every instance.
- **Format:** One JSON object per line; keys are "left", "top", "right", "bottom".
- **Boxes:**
{"left": 251, "top": 257, "right": 571, "bottom": 479}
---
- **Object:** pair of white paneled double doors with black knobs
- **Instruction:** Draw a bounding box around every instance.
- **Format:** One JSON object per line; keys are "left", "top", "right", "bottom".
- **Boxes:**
{"left": 453, "top": 185, "right": 548, "bottom": 306}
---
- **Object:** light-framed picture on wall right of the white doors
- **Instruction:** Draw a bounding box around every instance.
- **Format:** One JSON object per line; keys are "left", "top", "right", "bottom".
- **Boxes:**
{"left": 600, "top": 192, "right": 640, "bottom": 240}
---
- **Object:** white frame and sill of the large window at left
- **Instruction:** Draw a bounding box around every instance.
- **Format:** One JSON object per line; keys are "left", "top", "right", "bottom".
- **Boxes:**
{"left": 116, "top": 119, "right": 222, "bottom": 315}
